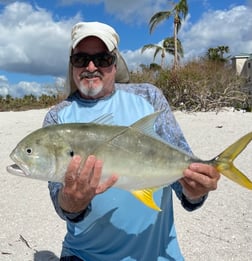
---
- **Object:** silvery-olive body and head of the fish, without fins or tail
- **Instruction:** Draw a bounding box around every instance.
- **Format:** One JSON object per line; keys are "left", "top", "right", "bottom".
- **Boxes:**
{"left": 7, "top": 117, "right": 192, "bottom": 190}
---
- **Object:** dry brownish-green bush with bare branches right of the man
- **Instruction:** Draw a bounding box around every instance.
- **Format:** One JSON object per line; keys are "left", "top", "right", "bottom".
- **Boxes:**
{"left": 131, "top": 58, "right": 252, "bottom": 111}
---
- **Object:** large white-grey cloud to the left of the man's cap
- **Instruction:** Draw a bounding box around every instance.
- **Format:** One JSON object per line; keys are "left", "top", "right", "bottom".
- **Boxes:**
{"left": 0, "top": 2, "right": 80, "bottom": 76}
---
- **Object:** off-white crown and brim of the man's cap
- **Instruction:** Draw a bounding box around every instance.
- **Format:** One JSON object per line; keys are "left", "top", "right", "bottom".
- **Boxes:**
{"left": 71, "top": 22, "right": 120, "bottom": 52}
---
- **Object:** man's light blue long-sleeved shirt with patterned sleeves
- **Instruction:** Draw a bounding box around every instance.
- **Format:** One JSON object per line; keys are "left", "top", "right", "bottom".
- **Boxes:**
{"left": 44, "top": 84, "right": 205, "bottom": 261}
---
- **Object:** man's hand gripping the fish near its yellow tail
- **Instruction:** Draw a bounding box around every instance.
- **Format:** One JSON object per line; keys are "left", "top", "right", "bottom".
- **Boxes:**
{"left": 180, "top": 163, "right": 220, "bottom": 200}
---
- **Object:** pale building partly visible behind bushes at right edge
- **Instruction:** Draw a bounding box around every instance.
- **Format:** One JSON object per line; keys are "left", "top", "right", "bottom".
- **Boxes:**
{"left": 232, "top": 53, "right": 252, "bottom": 83}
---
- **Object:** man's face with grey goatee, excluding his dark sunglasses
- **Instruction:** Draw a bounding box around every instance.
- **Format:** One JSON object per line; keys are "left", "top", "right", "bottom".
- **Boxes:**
{"left": 73, "top": 36, "right": 116, "bottom": 99}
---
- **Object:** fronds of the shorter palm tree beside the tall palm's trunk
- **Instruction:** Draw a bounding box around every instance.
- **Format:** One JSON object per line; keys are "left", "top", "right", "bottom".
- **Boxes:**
{"left": 141, "top": 37, "right": 184, "bottom": 69}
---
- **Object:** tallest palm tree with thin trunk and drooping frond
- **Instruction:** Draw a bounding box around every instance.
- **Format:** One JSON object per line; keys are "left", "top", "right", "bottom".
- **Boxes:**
{"left": 149, "top": 0, "right": 188, "bottom": 69}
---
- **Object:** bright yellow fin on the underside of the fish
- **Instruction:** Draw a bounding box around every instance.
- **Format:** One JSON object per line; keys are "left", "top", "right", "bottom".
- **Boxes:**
{"left": 131, "top": 188, "right": 161, "bottom": 211}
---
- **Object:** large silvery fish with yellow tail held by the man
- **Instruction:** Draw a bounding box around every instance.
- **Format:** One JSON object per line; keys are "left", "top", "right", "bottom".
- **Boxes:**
{"left": 7, "top": 111, "right": 252, "bottom": 211}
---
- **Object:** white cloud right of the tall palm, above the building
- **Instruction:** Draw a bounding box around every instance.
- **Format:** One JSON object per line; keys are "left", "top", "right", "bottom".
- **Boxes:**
{"left": 179, "top": 6, "right": 252, "bottom": 59}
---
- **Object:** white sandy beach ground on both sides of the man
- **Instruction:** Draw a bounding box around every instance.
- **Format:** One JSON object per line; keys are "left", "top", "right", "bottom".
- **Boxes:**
{"left": 0, "top": 107, "right": 252, "bottom": 261}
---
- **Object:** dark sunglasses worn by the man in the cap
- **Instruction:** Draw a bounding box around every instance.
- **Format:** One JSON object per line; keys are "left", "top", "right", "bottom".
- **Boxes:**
{"left": 70, "top": 53, "right": 116, "bottom": 68}
